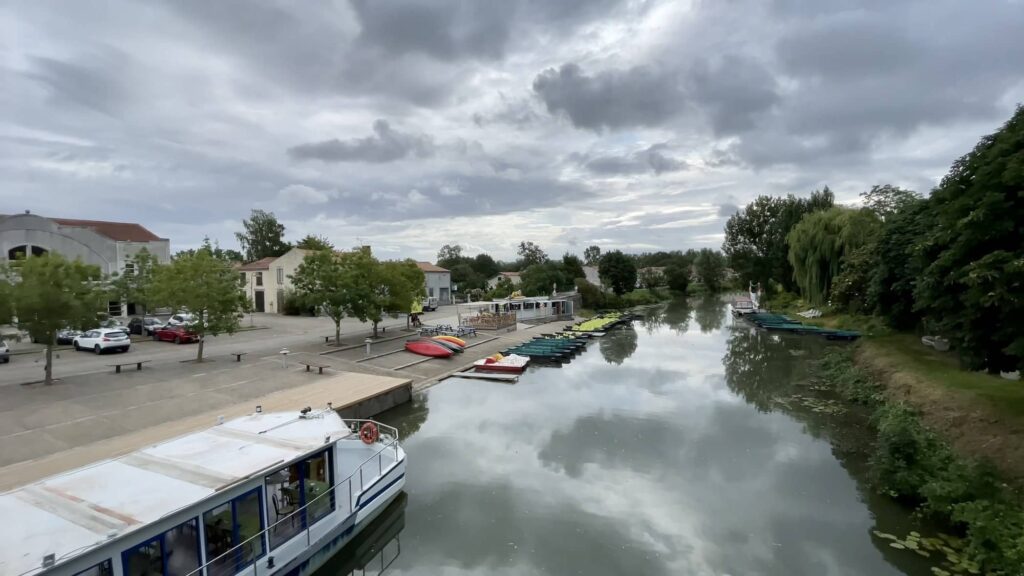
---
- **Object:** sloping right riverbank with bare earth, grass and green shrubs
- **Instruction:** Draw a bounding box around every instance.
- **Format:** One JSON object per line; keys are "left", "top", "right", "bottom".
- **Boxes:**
{"left": 817, "top": 342, "right": 1024, "bottom": 574}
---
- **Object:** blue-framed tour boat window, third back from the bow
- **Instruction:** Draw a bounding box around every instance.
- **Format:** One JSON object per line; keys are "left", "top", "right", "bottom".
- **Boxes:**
{"left": 122, "top": 519, "right": 200, "bottom": 576}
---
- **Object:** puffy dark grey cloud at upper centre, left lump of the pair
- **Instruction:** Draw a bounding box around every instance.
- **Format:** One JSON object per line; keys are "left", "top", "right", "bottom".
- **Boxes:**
{"left": 534, "top": 64, "right": 683, "bottom": 130}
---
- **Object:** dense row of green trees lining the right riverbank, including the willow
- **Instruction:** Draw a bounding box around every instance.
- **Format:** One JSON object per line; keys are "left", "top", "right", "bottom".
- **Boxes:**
{"left": 723, "top": 107, "right": 1024, "bottom": 373}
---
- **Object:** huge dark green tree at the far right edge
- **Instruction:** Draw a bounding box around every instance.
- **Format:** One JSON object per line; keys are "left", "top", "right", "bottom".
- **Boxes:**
{"left": 914, "top": 107, "right": 1024, "bottom": 372}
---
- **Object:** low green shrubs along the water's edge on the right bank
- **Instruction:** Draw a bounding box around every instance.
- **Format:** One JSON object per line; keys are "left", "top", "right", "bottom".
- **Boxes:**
{"left": 818, "top": 351, "right": 1024, "bottom": 575}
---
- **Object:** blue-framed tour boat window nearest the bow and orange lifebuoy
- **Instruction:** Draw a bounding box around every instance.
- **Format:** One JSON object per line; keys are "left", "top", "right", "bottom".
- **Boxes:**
{"left": 264, "top": 450, "right": 335, "bottom": 548}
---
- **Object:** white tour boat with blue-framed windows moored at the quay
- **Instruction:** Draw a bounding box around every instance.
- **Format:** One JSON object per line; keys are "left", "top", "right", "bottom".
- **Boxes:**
{"left": 0, "top": 407, "right": 406, "bottom": 576}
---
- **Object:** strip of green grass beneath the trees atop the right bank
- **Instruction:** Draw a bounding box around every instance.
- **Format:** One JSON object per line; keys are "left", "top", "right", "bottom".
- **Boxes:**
{"left": 865, "top": 334, "right": 1024, "bottom": 419}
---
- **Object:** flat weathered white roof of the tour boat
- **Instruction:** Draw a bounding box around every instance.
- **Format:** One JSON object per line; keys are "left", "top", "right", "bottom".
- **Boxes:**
{"left": 0, "top": 410, "right": 351, "bottom": 575}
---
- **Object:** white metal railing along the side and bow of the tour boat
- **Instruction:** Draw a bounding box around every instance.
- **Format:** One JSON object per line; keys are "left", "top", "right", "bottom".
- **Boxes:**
{"left": 185, "top": 418, "right": 398, "bottom": 576}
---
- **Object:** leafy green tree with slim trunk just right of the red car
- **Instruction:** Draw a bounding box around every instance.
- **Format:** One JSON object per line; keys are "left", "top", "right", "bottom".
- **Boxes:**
{"left": 152, "top": 248, "right": 249, "bottom": 362}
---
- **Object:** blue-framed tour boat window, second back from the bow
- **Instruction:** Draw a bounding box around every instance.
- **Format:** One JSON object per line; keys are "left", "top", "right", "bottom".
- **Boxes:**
{"left": 203, "top": 489, "right": 264, "bottom": 576}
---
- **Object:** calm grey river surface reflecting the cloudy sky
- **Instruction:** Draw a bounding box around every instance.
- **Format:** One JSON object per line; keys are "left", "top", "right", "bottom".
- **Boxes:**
{"left": 317, "top": 300, "right": 930, "bottom": 576}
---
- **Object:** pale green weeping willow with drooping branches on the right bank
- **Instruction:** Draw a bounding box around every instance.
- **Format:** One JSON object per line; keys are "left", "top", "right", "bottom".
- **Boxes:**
{"left": 786, "top": 206, "right": 881, "bottom": 305}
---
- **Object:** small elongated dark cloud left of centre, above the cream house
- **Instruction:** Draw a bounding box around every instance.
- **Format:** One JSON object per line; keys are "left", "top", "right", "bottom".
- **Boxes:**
{"left": 288, "top": 120, "right": 436, "bottom": 163}
